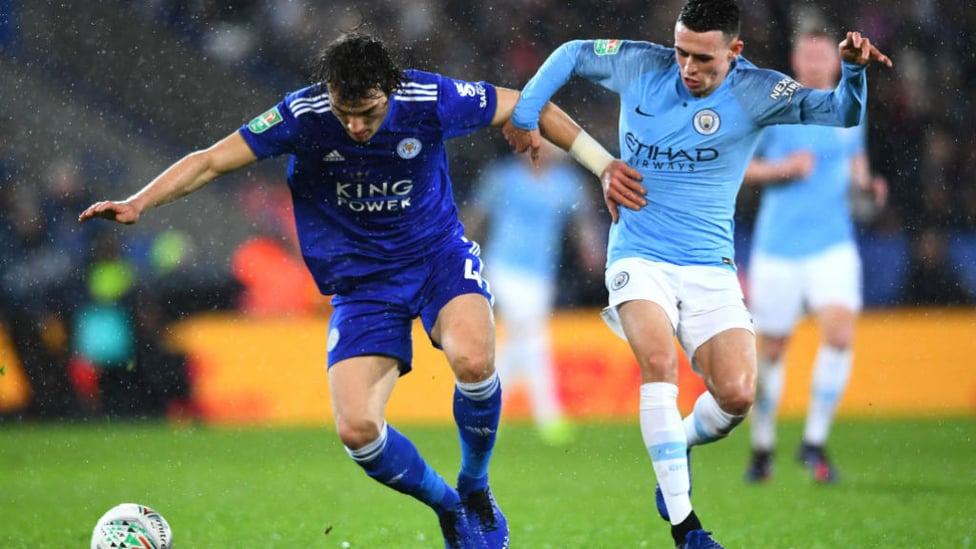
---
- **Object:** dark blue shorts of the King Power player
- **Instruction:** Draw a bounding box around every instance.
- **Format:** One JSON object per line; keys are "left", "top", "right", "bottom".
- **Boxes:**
{"left": 328, "top": 239, "right": 494, "bottom": 375}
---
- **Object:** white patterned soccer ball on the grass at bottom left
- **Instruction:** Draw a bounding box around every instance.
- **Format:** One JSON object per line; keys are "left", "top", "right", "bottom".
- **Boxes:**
{"left": 91, "top": 503, "right": 173, "bottom": 549}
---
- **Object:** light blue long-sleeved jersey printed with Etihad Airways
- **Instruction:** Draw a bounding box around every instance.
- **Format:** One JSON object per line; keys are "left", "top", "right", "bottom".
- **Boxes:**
{"left": 512, "top": 40, "right": 867, "bottom": 269}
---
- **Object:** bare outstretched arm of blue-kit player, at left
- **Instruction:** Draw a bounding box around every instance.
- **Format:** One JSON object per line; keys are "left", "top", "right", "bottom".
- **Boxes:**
{"left": 78, "top": 132, "right": 257, "bottom": 225}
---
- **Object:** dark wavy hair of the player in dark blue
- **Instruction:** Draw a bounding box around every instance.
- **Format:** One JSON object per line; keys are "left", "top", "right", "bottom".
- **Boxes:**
{"left": 312, "top": 30, "right": 406, "bottom": 101}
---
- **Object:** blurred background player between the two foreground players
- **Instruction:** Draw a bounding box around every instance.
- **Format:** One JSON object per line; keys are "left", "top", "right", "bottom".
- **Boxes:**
{"left": 463, "top": 142, "right": 605, "bottom": 445}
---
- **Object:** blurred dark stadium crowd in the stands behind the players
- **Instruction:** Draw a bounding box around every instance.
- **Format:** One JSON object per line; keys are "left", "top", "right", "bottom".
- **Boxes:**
{"left": 0, "top": 0, "right": 976, "bottom": 417}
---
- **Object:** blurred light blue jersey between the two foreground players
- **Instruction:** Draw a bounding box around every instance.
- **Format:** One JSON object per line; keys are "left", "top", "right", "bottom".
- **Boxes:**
{"left": 474, "top": 157, "right": 588, "bottom": 279}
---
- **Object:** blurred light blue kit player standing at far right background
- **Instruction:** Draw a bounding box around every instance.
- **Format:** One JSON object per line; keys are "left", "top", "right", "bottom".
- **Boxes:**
{"left": 745, "top": 33, "right": 888, "bottom": 483}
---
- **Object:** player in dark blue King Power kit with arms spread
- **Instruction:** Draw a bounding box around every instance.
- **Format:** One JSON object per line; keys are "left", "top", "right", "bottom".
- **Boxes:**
{"left": 79, "top": 32, "right": 608, "bottom": 549}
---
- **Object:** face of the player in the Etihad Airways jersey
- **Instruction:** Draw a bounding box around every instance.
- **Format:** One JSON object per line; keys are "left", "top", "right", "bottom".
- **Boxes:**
{"left": 674, "top": 22, "right": 743, "bottom": 97}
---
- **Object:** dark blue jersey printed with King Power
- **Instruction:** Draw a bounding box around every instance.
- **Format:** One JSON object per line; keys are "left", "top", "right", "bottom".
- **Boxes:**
{"left": 239, "top": 70, "right": 496, "bottom": 294}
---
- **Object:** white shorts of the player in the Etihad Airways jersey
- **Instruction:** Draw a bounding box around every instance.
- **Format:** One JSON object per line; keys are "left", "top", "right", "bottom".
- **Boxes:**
{"left": 602, "top": 257, "right": 753, "bottom": 371}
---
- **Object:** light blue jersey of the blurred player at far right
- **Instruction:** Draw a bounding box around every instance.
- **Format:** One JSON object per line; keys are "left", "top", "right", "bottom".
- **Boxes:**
{"left": 753, "top": 125, "right": 864, "bottom": 257}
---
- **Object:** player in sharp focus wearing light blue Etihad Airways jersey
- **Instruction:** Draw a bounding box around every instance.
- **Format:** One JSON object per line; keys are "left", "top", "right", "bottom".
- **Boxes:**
{"left": 509, "top": 0, "right": 890, "bottom": 547}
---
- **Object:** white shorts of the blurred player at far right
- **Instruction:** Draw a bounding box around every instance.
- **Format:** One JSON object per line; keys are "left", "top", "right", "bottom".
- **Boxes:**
{"left": 748, "top": 243, "right": 863, "bottom": 337}
